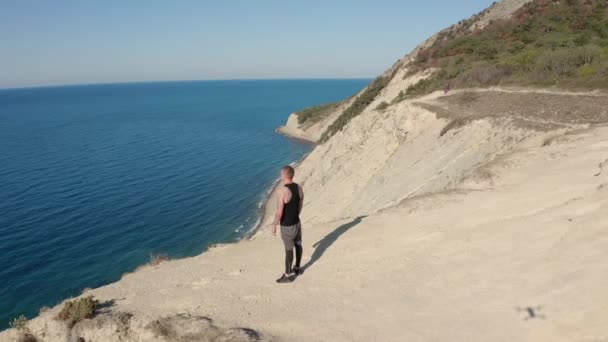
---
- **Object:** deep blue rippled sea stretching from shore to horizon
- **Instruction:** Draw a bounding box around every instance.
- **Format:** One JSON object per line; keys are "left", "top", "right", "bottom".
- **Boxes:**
{"left": 0, "top": 79, "right": 369, "bottom": 330}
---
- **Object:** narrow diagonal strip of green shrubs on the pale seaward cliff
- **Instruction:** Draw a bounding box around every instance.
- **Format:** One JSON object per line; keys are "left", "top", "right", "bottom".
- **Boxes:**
{"left": 319, "top": 70, "right": 396, "bottom": 143}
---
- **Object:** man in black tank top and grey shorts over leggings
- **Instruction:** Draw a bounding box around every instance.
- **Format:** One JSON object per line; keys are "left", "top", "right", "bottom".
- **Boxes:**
{"left": 272, "top": 166, "right": 304, "bottom": 283}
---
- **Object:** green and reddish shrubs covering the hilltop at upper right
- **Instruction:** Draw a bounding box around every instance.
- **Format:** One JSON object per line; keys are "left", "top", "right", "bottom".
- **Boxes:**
{"left": 395, "top": 0, "right": 608, "bottom": 102}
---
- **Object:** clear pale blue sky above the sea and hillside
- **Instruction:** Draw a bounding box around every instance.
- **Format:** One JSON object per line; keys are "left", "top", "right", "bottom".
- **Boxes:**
{"left": 0, "top": 0, "right": 493, "bottom": 88}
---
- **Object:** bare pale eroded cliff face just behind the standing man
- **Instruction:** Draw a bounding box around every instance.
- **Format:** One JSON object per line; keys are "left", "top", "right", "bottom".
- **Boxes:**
{"left": 290, "top": 74, "right": 545, "bottom": 222}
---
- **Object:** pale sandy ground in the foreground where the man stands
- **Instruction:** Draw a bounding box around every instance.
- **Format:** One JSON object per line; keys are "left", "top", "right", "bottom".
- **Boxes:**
{"left": 0, "top": 128, "right": 608, "bottom": 341}
